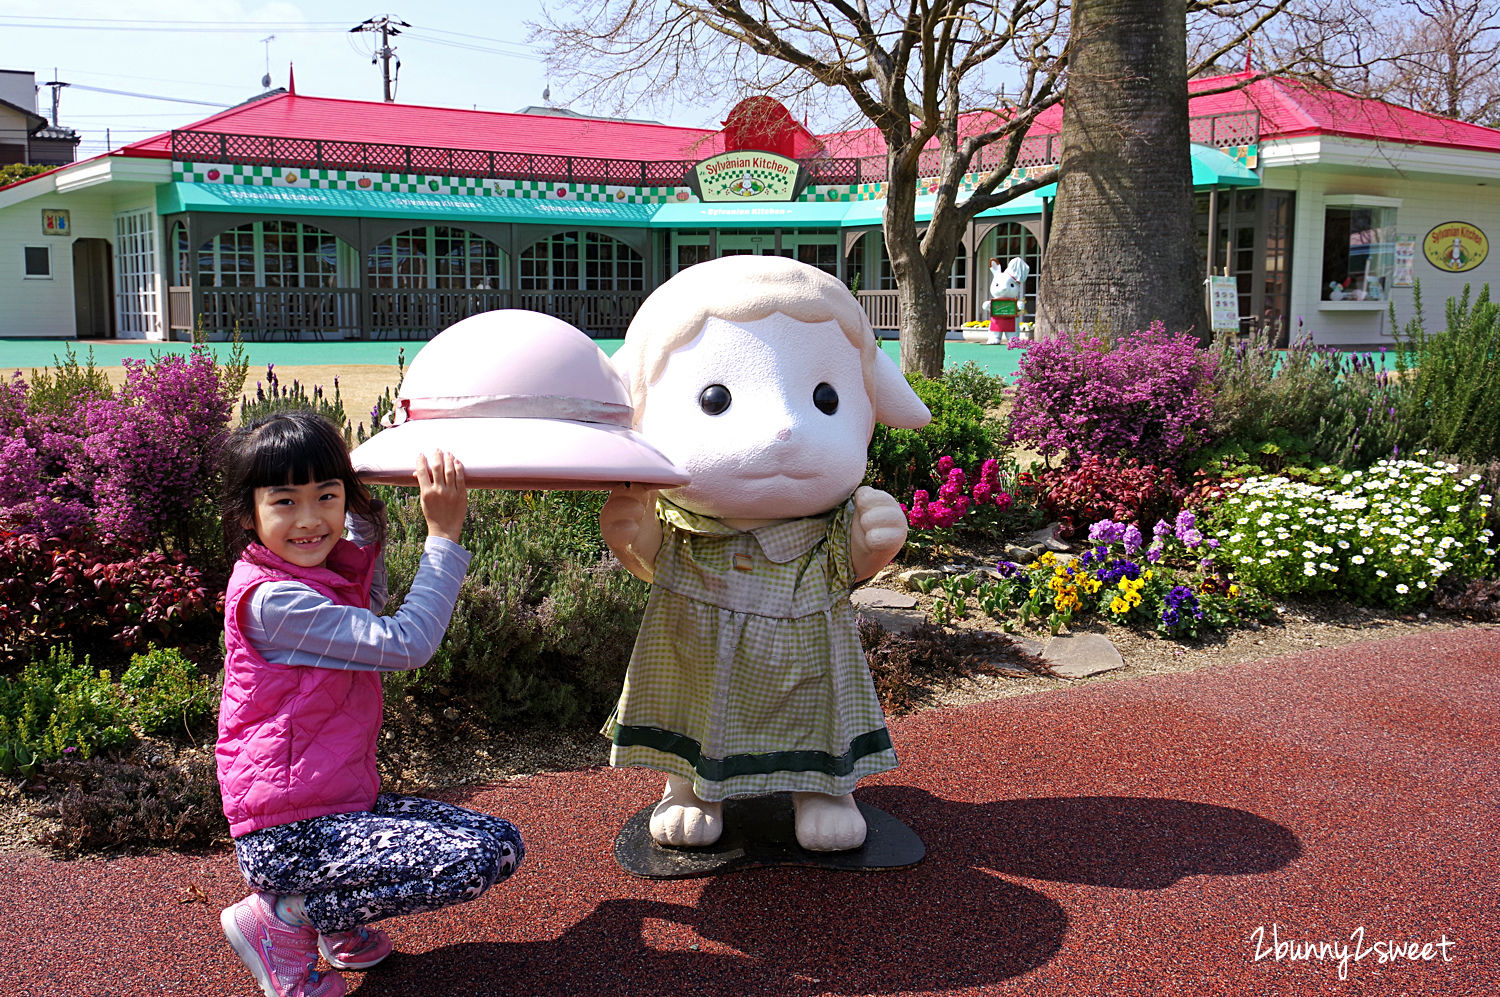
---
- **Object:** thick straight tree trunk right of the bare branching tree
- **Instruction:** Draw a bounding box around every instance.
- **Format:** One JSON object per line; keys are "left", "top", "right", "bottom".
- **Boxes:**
{"left": 1037, "top": 0, "right": 1208, "bottom": 340}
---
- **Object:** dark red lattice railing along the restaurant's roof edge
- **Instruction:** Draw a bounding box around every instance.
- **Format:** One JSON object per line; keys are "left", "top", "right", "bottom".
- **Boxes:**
{"left": 173, "top": 111, "right": 1260, "bottom": 187}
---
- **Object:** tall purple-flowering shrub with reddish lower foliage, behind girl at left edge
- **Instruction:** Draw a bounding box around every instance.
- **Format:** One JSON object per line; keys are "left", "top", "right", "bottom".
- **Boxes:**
{"left": 0, "top": 348, "right": 243, "bottom": 666}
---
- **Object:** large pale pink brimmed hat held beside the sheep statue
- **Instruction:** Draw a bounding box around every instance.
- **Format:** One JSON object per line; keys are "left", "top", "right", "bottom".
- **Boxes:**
{"left": 350, "top": 309, "right": 689, "bottom": 490}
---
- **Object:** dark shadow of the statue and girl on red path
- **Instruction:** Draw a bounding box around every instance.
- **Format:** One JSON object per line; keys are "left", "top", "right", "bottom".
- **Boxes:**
{"left": 356, "top": 786, "right": 1301, "bottom": 997}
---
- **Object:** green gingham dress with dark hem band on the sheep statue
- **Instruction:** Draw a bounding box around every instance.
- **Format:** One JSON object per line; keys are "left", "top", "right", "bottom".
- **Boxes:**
{"left": 603, "top": 498, "right": 896, "bottom": 802}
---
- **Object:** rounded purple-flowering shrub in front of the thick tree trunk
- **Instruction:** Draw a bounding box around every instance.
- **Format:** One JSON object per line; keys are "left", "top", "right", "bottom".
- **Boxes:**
{"left": 1010, "top": 322, "right": 1218, "bottom": 466}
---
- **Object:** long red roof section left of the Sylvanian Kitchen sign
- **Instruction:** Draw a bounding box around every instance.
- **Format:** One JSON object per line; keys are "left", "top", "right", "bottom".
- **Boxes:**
{"left": 119, "top": 93, "right": 723, "bottom": 162}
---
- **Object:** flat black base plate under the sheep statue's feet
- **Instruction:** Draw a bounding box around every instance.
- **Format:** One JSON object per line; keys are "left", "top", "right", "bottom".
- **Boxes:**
{"left": 615, "top": 793, "right": 927, "bottom": 879}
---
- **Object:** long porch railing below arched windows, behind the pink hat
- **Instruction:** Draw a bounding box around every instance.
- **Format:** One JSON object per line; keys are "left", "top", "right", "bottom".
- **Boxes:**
{"left": 168, "top": 286, "right": 647, "bottom": 340}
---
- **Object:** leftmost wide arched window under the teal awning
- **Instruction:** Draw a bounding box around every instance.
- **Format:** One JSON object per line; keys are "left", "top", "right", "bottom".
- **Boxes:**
{"left": 196, "top": 219, "right": 339, "bottom": 288}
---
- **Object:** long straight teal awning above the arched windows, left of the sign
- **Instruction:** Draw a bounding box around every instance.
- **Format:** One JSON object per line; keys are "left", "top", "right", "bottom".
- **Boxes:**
{"left": 156, "top": 181, "right": 657, "bottom": 228}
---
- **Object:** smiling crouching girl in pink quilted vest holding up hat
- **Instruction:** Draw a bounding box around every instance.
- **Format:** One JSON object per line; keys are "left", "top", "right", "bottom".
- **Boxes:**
{"left": 215, "top": 412, "right": 525, "bottom": 997}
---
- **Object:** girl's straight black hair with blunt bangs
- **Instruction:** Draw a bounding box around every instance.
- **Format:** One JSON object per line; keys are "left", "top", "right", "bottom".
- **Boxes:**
{"left": 221, "top": 409, "right": 386, "bottom": 564}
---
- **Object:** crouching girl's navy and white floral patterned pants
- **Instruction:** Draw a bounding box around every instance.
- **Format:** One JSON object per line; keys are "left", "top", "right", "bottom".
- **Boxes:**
{"left": 234, "top": 793, "right": 527, "bottom": 933}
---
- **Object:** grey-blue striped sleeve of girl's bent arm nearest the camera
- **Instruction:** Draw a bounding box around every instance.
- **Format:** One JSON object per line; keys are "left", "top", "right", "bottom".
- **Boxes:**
{"left": 242, "top": 537, "right": 470, "bottom": 672}
